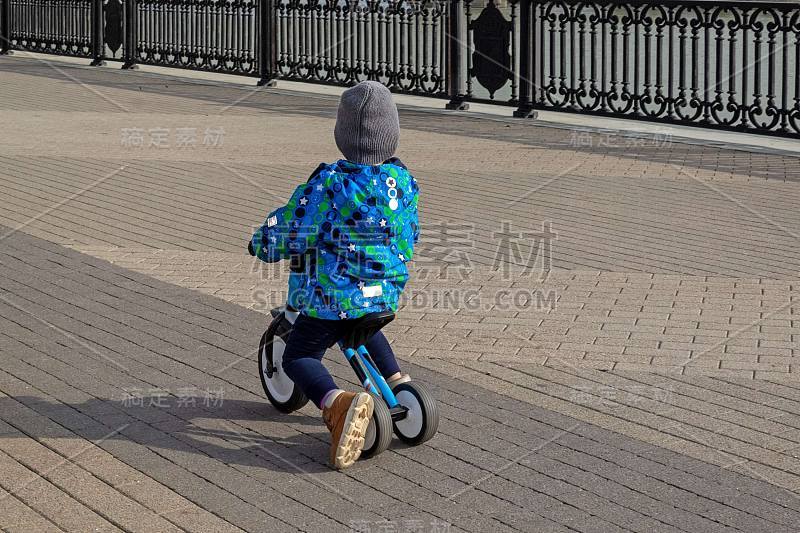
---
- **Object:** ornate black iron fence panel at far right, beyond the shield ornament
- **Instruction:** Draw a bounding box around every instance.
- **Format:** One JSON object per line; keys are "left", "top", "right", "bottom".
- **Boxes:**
{"left": 518, "top": 0, "right": 800, "bottom": 135}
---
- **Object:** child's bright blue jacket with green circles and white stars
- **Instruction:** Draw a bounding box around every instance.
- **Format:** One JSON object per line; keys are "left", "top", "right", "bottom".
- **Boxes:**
{"left": 250, "top": 158, "right": 419, "bottom": 320}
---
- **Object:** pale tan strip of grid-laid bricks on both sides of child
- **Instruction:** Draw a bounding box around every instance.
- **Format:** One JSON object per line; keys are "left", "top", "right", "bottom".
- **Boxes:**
{"left": 80, "top": 248, "right": 800, "bottom": 382}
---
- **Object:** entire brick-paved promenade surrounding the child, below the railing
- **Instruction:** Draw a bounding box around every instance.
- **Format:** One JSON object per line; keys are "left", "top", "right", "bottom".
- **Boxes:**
{"left": 0, "top": 52, "right": 800, "bottom": 532}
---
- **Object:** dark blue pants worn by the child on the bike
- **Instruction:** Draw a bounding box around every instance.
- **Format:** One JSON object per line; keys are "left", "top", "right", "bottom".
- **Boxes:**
{"left": 283, "top": 315, "right": 400, "bottom": 408}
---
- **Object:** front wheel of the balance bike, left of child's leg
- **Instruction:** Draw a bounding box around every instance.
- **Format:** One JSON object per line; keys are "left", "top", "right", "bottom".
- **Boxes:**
{"left": 258, "top": 313, "right": 308, "bottom": 413}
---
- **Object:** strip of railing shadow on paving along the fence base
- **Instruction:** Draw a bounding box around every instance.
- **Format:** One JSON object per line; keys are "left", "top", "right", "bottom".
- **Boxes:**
{"left": 0, "top": 54, "right": 800, "bottom": 181}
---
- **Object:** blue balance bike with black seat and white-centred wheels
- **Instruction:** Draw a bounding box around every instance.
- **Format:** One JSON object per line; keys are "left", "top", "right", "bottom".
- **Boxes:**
{"left": 258, "top": 307, "right": 439, "bottom": 458}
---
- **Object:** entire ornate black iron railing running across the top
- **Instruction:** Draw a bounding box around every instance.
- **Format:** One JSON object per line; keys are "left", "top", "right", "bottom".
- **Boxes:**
{"left": 0, "top": 0, "right": 800, "bottom": 136}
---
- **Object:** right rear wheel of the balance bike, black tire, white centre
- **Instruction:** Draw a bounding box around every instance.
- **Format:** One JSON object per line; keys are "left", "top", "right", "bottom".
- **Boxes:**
{"left": 392, "top": 381, "right": 439, "bottom": 446}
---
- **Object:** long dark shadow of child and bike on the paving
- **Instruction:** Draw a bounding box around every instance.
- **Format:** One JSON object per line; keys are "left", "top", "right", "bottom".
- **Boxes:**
{"left": 0, "top": 395, "right": 346, "bottom": 474}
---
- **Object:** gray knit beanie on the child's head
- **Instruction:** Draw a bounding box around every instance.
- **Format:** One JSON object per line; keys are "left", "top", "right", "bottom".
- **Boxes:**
{"left": 333, "top": 81, "right": 400, "bottom": 165}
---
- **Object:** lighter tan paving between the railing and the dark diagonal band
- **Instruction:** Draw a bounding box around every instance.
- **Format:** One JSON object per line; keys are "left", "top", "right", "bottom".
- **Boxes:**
{"left": 0, "top": 58, "right": 800, "bottom": 379}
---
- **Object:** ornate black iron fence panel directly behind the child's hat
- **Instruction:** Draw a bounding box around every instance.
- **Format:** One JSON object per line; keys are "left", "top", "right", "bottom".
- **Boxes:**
{"left": 276, "top": 0, "right": 447, "bottom": 96}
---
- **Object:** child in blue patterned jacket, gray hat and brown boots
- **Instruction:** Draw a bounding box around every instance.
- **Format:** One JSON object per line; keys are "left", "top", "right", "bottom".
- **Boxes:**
{"left": 250, "top": 81, "right": 419, "bottom": 468}
